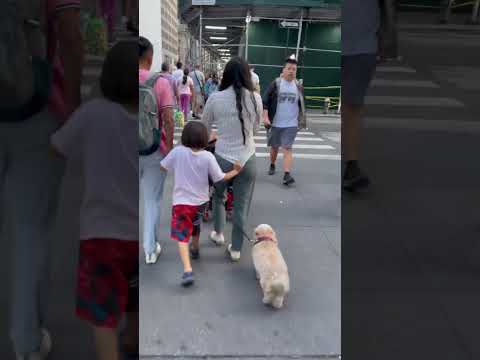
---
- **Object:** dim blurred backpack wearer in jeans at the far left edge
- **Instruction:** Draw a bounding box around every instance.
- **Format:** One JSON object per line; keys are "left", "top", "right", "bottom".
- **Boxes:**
{"left": 0, "top": 0, "right": 84, "bottom": 360}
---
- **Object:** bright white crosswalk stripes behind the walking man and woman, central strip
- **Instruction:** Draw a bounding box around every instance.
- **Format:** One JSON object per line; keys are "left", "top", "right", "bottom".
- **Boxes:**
{"left": 174, "top": 127, "right": 340, "bottom": 160}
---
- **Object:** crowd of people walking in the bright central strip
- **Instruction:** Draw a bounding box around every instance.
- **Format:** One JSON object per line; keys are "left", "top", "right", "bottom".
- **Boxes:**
{"left": 139, "top": 37, "right": 306, "bottom": 286}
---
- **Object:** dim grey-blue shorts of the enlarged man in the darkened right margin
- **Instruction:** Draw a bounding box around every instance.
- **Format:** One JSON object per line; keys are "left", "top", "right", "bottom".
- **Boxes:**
{"left": 341, "top": 54, "right": 377, "bottom": 105}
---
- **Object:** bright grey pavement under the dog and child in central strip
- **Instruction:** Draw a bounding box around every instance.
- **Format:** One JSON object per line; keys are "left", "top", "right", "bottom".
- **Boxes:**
{"left": 140, "top": 124, "right": 341, "bottom": 360}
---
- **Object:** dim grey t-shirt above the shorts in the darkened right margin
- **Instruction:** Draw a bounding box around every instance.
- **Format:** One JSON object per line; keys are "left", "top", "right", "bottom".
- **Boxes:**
{"left": 342, "top": 0, "right": 380, "bottom": 55}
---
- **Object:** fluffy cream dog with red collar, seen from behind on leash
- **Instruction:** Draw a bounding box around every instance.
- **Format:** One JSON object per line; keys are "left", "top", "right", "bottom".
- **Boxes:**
{"left": 252, "top": 224, "right": 290, "bottom": 309}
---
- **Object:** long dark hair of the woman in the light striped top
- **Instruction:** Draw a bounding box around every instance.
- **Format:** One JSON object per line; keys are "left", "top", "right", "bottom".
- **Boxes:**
{"left": 219, "top": 57, "right": 258, "bottom": 145}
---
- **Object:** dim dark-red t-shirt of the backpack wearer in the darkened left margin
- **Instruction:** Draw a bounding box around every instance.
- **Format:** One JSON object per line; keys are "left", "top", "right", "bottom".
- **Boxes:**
{"left": 47, "top": 0, "right": 80, "bottom": 121}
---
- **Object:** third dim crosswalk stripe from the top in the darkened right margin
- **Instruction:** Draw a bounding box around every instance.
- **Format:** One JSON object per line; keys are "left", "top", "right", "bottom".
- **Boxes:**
{"left": 365, "top": 96, "right": 465, "bottom": 107}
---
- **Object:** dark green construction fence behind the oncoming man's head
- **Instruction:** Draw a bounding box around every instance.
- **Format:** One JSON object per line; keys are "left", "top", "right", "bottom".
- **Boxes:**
{"left": 248, "top": 20, "right": 340, "bottom": 109}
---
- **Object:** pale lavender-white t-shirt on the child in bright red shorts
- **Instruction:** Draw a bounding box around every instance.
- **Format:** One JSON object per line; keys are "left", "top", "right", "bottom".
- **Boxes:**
{"left": 160, "top": 145, "right": 225, "bottom": 206}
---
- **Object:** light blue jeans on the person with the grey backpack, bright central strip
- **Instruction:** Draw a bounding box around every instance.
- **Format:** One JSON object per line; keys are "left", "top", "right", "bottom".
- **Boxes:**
{"left": 139, "top": 152, "right": 167, "bottom": 254}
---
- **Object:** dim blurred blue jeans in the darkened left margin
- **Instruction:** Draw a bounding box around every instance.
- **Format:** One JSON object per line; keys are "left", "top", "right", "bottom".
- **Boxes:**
{"left": 0, "top": 111, "right": 64, "bottom": 354}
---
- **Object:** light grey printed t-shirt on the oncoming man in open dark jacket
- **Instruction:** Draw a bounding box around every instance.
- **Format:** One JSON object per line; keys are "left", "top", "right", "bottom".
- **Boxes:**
{"left": 273, "top": 79, "right": 300, "bottom": 128}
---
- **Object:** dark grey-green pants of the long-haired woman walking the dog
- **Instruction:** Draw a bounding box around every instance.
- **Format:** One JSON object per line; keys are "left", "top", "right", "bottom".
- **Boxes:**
{"left": 213, "top": 155, "right": 257, "bottom": 251}
